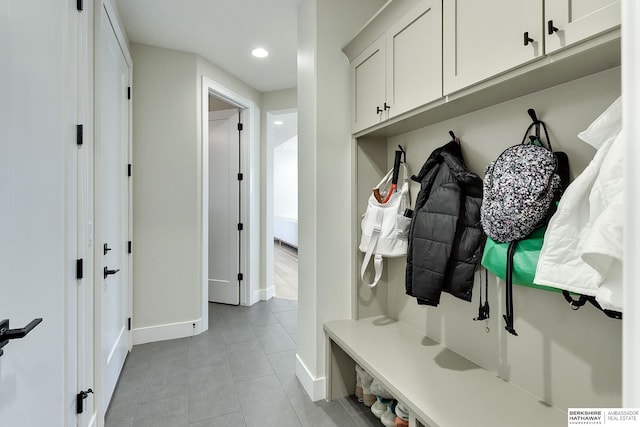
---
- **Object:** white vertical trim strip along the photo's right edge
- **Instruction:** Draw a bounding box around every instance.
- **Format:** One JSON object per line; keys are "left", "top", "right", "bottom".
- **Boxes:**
{"left": 621, "top": 0, "right": 640, "bottom": 408}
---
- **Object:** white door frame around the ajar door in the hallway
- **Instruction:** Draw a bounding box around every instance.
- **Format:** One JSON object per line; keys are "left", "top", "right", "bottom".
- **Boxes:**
{"left": 198, "top": 76, "right": 260, "bottom": 330}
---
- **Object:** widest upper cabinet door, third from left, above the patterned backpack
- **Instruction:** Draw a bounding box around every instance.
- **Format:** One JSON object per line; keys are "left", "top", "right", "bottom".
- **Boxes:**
{"left": 443, "top": 0, "right": 544, "bottom": 94}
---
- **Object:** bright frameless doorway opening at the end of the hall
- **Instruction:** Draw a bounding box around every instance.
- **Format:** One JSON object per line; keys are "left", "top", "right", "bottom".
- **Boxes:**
{"left": 267, "top": 111, "right": 298, "bottom": 300}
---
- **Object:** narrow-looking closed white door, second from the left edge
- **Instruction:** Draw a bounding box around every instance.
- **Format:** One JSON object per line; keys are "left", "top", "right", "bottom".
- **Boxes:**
{"left": 95, "top": 5, "right": 129, "bottom": 413}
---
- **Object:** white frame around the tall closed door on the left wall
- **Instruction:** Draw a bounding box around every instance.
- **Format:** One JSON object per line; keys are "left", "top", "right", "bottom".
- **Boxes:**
{"left": 92, "top": 0, "right": 133, "bottom": 427}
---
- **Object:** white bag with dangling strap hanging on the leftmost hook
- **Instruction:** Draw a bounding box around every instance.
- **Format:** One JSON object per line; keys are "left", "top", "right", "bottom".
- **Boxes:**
{"left": 359, "top": 163, "right": 411, "bottom": 288}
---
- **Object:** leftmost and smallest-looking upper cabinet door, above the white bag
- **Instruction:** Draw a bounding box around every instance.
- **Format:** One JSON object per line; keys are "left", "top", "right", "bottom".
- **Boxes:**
{"left": 351, "top": 37, "right": 386, "bottom": 132}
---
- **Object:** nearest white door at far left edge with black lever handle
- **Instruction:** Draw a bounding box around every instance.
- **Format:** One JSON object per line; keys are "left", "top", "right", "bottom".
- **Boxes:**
{"left": 0, "top": 0, "right": 82, "bottom": 427}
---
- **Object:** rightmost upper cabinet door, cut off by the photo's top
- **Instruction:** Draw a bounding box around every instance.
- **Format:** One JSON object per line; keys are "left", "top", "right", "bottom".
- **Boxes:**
{"left": 545, "top": 0, "right": 620, "bottom": 53}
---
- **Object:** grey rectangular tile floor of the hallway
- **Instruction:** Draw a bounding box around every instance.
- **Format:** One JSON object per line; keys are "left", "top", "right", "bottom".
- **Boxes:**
{"left": 106, "top": 298, "right": 382, "bottom": 427}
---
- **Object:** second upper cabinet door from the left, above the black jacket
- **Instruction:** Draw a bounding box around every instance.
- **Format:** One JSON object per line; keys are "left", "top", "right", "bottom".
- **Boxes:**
{"left": 386, "top": 0, "right": 442, "bottom": 117}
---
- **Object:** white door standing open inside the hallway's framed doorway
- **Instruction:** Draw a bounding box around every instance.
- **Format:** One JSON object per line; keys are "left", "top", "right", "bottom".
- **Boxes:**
{"left": 209, "top": 110, "right": 242, "bottom": 304}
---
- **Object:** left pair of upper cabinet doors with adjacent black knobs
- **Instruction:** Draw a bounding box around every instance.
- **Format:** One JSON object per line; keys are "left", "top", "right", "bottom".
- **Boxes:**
{"left": 351, "top": 0, "right": 442, "bottom": 132}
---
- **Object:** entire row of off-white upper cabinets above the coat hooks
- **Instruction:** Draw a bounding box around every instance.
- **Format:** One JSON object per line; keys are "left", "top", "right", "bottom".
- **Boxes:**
{"left": 343, "top": 0, "right": 621, "bottom": 133}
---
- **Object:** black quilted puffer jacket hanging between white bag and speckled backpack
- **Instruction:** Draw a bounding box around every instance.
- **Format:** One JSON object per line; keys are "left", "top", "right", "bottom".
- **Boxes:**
{"left": 406, "top": 141, "right": 484, "bottom": 306}
